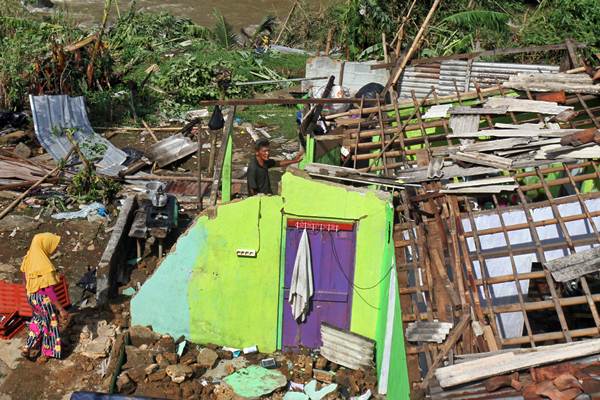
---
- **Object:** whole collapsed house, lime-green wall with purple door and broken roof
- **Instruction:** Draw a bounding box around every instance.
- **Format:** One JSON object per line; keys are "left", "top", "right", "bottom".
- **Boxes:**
{"left": 127, "top": 39, "right": 600, "bottom": 399}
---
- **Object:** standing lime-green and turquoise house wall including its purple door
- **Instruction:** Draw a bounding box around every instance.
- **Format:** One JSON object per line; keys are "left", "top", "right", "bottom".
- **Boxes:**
{"left": 131, "top": 172, "right": 408, "bottom": 398}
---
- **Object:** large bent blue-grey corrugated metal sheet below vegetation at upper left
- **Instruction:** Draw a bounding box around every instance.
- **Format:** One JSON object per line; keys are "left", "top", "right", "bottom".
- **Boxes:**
{"left": 29, "top": 95, "right": 127, "bottom": 172}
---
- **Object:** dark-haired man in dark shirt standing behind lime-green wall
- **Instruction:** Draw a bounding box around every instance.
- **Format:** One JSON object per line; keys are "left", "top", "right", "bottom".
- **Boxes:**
{"left": 248, "top": 139, "right": 304, "bottom": 196}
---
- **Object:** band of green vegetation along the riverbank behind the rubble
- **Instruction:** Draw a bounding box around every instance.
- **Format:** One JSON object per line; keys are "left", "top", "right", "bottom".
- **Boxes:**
{"left": 0, "top": 0, "right": 600, "bottom": 128}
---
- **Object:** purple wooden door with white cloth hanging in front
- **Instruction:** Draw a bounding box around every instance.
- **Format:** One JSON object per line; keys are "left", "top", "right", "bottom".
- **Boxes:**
{"left": 282, "top": 225, "right": 355, "bottom": 348}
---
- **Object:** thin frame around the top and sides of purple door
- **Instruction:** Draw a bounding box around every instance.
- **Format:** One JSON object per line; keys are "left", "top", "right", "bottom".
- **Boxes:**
{"left": 277, "top": 211, "right": 359, "bottom": 350}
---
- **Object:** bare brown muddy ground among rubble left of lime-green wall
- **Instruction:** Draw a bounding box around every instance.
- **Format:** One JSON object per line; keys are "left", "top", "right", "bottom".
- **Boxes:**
{"left": 0, "top": 120, "right": 298, "bottom": 400}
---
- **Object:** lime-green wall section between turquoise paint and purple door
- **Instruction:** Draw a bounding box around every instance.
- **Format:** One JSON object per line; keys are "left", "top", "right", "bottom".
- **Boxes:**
{"left": 188, "top": 196, "right": 282, "bottom": 352}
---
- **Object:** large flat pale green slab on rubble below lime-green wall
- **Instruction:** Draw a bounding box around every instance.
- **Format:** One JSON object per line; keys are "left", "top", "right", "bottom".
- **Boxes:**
{"left": 225, "top": 365, "right": 287, "bottom": 398}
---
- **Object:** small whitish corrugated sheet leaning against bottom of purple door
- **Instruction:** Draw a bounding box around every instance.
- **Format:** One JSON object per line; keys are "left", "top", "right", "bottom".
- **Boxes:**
{"left": 321, "top": 323, "right": 375, "bottom": 369}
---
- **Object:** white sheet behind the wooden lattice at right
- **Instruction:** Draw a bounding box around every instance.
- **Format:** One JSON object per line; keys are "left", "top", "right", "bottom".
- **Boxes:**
{"left": 462, "top": 199, "right": 600, "bottom": 338}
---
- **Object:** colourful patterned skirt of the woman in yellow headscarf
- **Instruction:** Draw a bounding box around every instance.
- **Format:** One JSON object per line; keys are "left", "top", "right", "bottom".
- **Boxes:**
{"left": 27, "top": 292, "right": 61, "bottom": 358}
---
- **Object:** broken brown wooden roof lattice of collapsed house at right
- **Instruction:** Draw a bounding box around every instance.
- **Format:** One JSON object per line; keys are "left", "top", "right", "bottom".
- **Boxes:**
{"left": 316, "top": 72, "right": 600, "bottom": 394}
